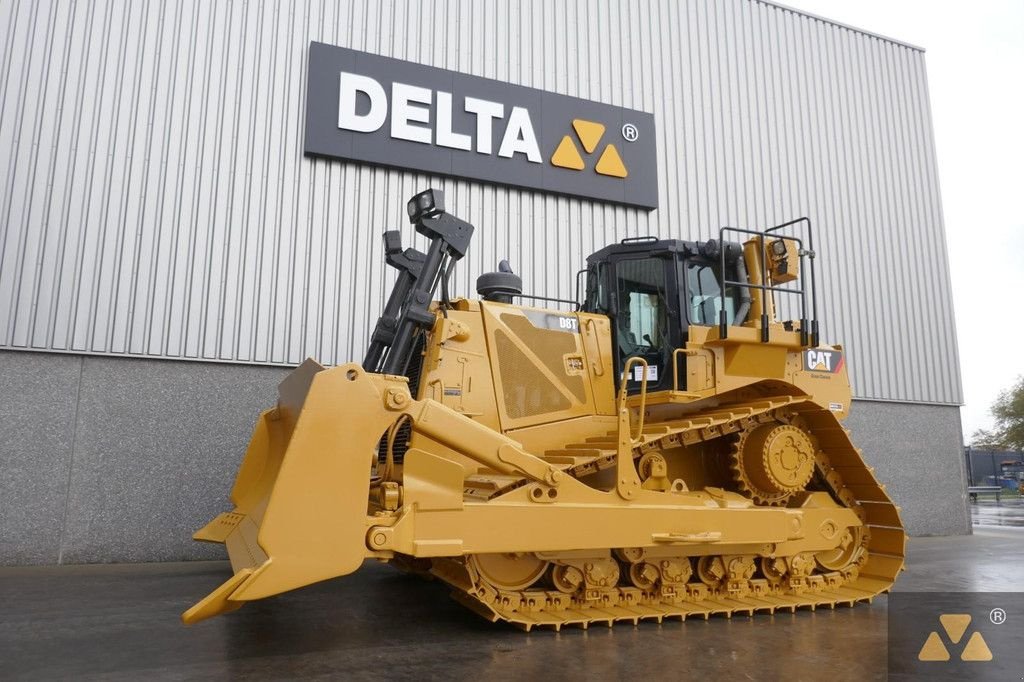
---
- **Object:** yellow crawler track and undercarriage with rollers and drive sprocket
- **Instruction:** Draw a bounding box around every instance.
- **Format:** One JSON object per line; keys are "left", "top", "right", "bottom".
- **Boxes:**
{"left": 395, "top": 399, "right": 904, "bottom": 630}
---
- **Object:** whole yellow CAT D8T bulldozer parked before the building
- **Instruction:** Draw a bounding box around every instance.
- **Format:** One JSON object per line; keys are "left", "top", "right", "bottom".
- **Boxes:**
{"left": 182, "top": 189, "right": 905, "bottom": 631}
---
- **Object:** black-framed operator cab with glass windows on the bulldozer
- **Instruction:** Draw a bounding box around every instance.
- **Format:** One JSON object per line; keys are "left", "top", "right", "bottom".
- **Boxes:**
{"left": 583, "top": 237, "right": 750, "bottom": 393}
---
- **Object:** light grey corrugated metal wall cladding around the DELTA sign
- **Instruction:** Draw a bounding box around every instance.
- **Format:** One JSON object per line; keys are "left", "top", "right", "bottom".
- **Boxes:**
{"left": 0, "top": 0, "right": 961, "bottom": 402}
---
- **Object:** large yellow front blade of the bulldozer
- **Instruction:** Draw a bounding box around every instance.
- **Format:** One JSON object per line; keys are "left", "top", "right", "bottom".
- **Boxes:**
{"left": 182, "top": 360, "right": 408, "bottom": 624}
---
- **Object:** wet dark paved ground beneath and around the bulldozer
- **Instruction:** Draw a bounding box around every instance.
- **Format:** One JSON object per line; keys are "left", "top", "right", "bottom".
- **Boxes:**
{"left": 0, "top": 503, "right": 1024, "bottom": 682}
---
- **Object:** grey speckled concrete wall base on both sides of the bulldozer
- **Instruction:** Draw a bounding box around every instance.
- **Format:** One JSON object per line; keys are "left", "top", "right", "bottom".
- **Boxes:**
{"left": 0, "top": 351, "right": 970, "bottom": 565}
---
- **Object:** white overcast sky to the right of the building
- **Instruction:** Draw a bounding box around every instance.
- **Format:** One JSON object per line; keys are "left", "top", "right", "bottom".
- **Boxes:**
{"left": 782, "top": 0, "right": 1024, "bottom": 438}
